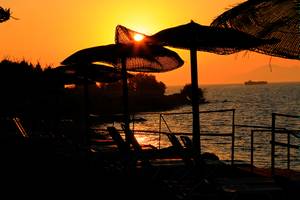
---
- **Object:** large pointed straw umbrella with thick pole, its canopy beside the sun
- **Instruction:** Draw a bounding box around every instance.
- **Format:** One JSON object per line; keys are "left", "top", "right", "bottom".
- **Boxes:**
{"left": 118, "top": 21, "right": 275, "bottom": 153}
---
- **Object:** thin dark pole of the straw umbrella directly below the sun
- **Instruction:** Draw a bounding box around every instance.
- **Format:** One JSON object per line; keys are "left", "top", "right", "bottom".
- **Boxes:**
{"left": 121, "top": 58, "right": 130, "bottom": 141}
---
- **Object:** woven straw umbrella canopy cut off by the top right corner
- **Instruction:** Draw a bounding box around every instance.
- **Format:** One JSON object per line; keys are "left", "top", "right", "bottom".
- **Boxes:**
{"left": 211, "top": 0, "right": 300, "bottom": 60}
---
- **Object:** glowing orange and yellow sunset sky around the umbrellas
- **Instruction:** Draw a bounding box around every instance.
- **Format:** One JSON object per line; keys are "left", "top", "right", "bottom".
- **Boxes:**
{"left": 0, "top": 0, "right": 300, "bottom": 86}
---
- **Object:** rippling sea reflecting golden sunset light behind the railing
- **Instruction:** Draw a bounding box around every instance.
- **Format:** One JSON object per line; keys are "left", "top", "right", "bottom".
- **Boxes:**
{"left": 94, "top": 83, "right": 300, "bottom": 170}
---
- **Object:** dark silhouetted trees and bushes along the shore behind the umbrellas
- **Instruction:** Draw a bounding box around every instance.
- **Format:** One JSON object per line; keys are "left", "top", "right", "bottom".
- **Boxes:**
{"left": 0, "top": 60, "right": 205, "bottom": 118}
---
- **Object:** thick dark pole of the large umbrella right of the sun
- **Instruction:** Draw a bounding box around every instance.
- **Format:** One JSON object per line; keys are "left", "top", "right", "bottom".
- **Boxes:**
{"left": 190, "top": 48, "right": 201, "bottom": 154}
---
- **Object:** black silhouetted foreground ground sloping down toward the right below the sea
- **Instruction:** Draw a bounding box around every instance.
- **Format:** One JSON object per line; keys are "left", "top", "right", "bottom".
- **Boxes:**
{"left": 0, "top": 118, "right": 300, "bottom": 199}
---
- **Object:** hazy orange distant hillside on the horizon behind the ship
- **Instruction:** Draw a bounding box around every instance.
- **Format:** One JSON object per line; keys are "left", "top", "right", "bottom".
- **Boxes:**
{"left": 229, "top": 65, "right": 300, "bottom": 83}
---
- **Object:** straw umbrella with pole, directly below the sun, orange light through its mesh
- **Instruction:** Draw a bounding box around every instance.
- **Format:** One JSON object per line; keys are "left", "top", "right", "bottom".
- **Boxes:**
{"left": 62, "top": 43, "right": 183, "bottom": 141}
